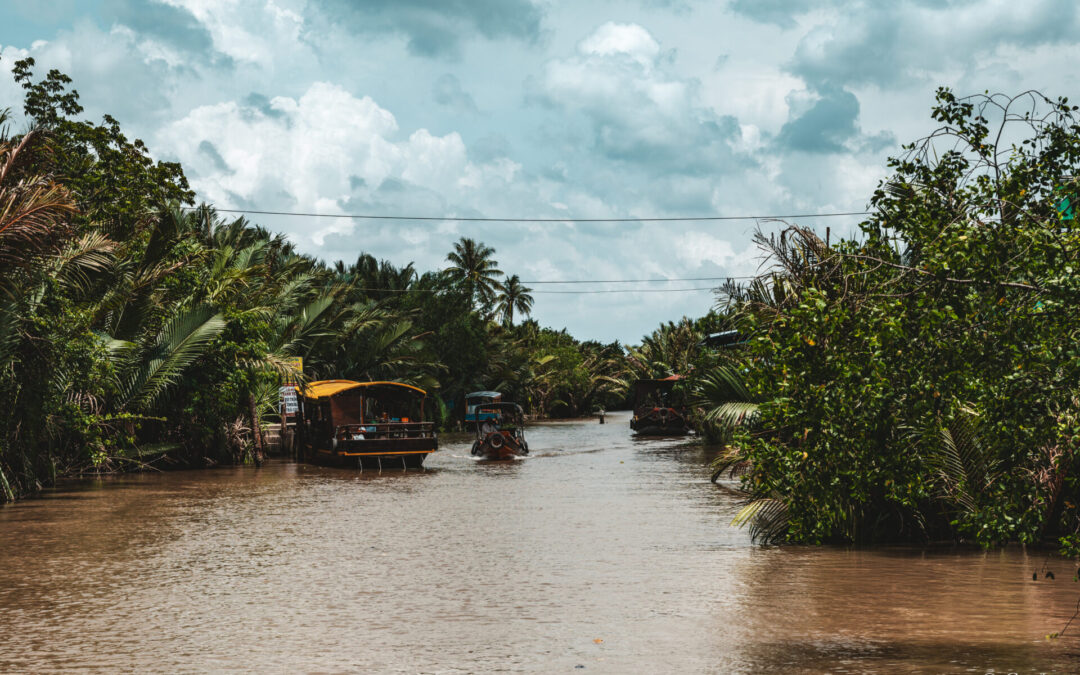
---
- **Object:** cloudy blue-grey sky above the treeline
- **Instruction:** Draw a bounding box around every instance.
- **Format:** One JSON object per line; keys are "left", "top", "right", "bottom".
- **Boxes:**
{"left": 0, "top": 0, "right": 1080, "bottom": 343}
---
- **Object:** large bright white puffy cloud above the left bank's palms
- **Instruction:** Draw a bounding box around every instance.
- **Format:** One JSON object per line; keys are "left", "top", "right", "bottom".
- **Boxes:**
{"left": 157, "top": 82, "right": 521, "bottom": 245}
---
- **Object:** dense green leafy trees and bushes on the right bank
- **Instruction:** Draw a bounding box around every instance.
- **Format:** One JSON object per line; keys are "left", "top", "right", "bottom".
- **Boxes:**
{"left": 696, "top": 89, "right": 1080, "bottom": 554}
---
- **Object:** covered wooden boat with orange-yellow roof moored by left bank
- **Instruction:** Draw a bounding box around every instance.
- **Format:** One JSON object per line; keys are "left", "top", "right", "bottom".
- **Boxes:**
{"left": 297, "top": 380, "right": 438, "bottom": 469}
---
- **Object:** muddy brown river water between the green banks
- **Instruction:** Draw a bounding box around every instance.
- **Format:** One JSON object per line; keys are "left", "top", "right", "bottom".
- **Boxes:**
{"left": 0, "top": 414, "right": 1080, "bottom": 673}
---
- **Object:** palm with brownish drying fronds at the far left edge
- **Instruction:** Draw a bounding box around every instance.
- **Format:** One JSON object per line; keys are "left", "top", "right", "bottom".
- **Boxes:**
{"left": 0, "top": 119, "right": 98, "bottom": 502}
